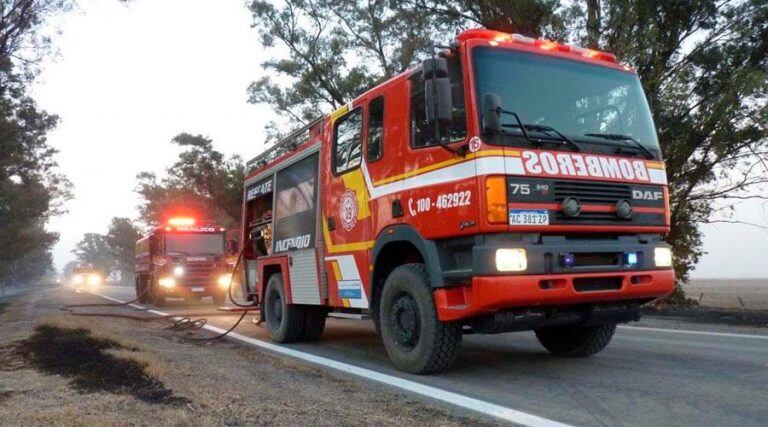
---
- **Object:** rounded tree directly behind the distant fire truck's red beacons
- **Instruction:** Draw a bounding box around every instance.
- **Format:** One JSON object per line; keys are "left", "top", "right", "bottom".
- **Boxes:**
{"left": 136, "top": 133, "right": 245, "bottom": 227}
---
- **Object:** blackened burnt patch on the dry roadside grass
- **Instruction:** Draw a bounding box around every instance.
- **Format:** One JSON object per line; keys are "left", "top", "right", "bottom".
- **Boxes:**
{"left": 17, "top": 325, "right": 189, "bottom": 405}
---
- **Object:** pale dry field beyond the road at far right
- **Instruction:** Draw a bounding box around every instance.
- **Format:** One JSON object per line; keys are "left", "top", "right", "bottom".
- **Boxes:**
{"left": 683, "top": 278, "right": 768, "bottom": 310}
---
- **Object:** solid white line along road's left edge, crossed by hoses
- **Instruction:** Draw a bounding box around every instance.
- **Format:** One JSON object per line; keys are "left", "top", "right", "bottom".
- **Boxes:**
{"left": 88, "top": 292, "right": 569, "bottom": 427}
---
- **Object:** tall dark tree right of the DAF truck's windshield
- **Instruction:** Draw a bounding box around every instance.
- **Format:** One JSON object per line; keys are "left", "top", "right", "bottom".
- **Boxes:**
{"left": 572, "top": 0, "right": 768, "bottom": 295}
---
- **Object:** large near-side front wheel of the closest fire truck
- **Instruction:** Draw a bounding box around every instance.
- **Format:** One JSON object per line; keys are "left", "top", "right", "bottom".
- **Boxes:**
{"left": 379, "top": 264, "right": 461, "bottom": 374}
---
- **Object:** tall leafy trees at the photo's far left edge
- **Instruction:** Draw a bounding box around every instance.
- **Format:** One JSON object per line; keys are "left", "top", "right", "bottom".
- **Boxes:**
{"left": 0, "top": 0, "right": 70, "bottom": 292}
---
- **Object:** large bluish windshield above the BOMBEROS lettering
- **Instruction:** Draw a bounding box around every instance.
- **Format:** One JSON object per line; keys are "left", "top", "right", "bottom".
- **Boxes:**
{"left": 473, "top": 47, "right": 659, "bottom": 150}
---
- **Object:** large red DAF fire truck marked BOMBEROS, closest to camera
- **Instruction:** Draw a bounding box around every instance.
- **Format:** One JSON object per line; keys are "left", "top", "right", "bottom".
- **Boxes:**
{"left": 242, "top": 29, "right": 674, "bottom": 373}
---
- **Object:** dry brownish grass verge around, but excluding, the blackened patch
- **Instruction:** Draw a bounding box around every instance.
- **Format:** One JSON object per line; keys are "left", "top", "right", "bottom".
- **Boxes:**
{"left": 0, "top": 291, "right": 484, "bottom": 426}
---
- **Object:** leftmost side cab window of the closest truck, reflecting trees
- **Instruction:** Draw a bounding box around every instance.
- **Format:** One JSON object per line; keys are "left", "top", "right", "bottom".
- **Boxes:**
{"left": 333, "top": 108, "right": 363, "bottom": 175}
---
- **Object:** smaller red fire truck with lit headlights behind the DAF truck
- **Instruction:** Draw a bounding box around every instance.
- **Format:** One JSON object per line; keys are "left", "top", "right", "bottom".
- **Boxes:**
{"left": 136, "top": 218, "right": 232, "bottom": 306}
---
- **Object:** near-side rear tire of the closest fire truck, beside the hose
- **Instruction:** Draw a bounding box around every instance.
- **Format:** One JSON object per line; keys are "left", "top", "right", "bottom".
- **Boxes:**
{"left": 264, "top": 274, "right": 305, "bottom": 343}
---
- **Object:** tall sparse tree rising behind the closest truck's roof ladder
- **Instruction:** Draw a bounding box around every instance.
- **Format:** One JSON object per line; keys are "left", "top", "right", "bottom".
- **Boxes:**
{"left": 249, "top": 0, "right": 438, "bottom": 134}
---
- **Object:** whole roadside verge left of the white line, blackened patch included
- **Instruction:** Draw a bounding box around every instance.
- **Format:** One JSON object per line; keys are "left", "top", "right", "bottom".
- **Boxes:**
{"left": 0, "top": 289, "right": 489, "bottom": 426}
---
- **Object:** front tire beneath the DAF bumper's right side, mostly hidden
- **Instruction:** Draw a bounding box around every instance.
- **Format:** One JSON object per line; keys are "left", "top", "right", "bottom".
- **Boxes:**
{"left": 536, "top": 323, "right": 616, "bottom": 357}
